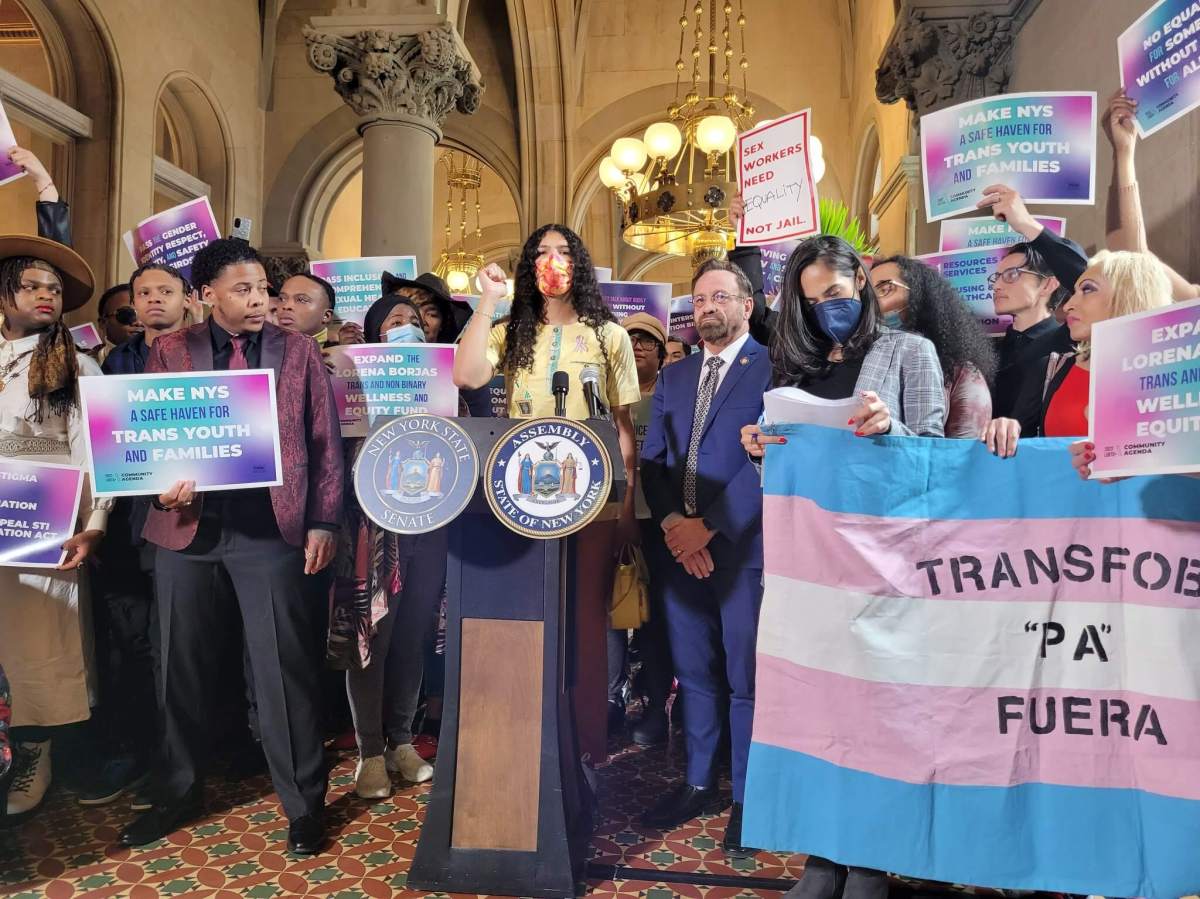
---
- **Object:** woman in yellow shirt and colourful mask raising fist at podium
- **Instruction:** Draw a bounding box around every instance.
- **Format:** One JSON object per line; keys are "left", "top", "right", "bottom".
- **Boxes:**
{"left": 454, "top": 224, "right": 641, "bottom": 765}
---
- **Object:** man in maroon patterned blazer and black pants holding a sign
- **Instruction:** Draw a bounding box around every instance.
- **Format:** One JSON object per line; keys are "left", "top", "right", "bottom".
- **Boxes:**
{"left": 120, "top": 238, "right": 343, "bottom": 855}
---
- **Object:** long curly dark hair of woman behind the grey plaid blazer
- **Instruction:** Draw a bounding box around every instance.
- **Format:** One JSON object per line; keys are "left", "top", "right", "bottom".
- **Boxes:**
{"left": 872, "top": 256, "right": 998, "bottom": 385}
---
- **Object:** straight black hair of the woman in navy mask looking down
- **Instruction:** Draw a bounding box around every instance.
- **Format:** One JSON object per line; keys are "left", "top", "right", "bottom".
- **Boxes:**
{"left": 768, "top": 234, "right": 880, "bottom": 385}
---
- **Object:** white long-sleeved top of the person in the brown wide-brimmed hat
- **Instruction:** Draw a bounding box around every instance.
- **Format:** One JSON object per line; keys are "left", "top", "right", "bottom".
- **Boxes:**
{"left": 0, "top": 334, "right": 113, "bottom": 531}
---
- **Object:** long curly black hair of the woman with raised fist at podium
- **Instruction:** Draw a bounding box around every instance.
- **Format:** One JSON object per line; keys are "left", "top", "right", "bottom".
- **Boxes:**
{"left": 499, "top": 224, "right": 617, "bottom": 374}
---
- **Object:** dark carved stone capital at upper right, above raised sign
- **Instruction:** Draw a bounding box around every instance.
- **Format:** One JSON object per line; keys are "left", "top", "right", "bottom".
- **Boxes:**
{"left": 875, "top": 0, "right": 1038, "bottom": 115}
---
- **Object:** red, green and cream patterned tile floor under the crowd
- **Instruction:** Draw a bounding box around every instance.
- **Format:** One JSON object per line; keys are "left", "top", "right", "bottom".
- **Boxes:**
{"left": 0, "top": 741, "right": 803, "bottom": 899}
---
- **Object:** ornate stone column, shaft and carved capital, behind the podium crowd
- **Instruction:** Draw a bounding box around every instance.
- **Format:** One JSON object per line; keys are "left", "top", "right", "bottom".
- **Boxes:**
{"left": 304, "top": 7, "right": 484, "bottom": 271}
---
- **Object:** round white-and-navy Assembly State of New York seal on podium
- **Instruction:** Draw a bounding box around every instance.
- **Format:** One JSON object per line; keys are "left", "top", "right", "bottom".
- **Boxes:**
{"left": 484, "top": 418, "right": 612, "bottom": 540}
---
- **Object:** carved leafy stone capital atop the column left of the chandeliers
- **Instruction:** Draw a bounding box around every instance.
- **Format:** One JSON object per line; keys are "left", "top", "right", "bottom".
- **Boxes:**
{"left": 304, "top": 22, "right": 484, "bottom": 139}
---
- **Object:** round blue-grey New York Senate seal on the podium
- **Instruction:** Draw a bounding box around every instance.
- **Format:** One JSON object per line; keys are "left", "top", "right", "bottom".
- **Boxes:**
{"left": 354, "top": 415, "right": 479, "bottom": 534}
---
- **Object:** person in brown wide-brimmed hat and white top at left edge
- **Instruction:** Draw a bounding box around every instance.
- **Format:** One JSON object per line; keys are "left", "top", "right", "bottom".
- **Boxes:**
{"left": 0, "top": 235, "right": 112, "bottom": 815}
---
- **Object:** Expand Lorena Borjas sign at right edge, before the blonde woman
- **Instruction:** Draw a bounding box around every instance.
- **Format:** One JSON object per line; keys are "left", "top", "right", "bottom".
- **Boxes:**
{"left": 1087, "top": 300, "right": 1200, "bottom": 478}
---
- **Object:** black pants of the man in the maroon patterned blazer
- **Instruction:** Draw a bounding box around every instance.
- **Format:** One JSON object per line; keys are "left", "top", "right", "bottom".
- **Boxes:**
{"left": 155, "top": 491, "right": 326, "bottom": 820}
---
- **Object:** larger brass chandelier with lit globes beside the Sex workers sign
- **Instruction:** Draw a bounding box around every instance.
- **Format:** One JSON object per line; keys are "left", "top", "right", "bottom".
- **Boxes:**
{"left": 599, "top": 0, "right": 755, "bottom": 263}
